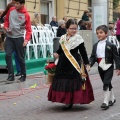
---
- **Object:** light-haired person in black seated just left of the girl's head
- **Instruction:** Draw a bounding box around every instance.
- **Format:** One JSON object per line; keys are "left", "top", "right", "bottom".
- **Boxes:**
{"left": 57, "top": 20, "right": 66, "bottom": 37}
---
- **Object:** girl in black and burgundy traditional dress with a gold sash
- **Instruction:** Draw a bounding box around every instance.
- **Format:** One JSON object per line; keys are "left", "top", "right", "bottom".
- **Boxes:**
{"left": 48, "top": 19, "right": 94, "bottom": 110}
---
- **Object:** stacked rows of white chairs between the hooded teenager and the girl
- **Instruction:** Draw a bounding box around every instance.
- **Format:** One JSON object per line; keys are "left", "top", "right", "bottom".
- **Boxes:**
{"left": 26, "top": 26, "right": 55, "bottom": 60}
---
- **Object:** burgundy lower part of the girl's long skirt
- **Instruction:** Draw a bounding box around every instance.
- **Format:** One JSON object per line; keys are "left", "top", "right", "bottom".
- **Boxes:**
{"left": 48, "top": 75, "right": 94, "bottom": 104}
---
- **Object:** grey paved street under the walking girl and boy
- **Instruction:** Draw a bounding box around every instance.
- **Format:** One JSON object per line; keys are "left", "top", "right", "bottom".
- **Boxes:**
{"left": 0, "top": 66, "right": 120, "bottom": 120}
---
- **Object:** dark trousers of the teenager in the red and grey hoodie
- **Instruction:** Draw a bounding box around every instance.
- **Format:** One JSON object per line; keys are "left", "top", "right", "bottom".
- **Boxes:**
{"left": 5, "top": 37, "right": 26, "bottom": 76}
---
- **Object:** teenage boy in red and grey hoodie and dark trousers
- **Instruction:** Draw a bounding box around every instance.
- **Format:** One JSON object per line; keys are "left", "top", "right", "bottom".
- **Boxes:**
{"left": 4, "top": 0, "right": 31, "bottom": 83}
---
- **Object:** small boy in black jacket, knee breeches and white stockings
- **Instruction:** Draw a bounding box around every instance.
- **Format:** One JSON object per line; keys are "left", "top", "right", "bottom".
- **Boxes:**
{"left": 90, "top": 25, "right": 120, "bottom": 109}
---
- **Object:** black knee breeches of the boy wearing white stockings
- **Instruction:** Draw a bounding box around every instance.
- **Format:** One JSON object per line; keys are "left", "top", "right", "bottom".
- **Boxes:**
{"left": 98, "top": 65, "right": 114, "bottom": 91}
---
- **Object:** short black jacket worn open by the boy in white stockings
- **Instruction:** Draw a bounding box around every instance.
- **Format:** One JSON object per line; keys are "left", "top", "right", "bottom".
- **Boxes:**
{"left": 89, "top": 40, "right": 120, "bottom": 70}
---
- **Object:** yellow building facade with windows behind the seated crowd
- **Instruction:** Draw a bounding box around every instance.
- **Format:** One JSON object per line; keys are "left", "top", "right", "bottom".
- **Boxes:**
{"left": 0, "top": 0, "right": 116, "bottom": 24}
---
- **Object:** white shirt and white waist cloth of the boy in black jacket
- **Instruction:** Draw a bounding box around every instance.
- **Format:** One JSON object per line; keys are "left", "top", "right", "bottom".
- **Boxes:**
{"left": 96, "top": 39, "right": 112, "bottom": 70}
